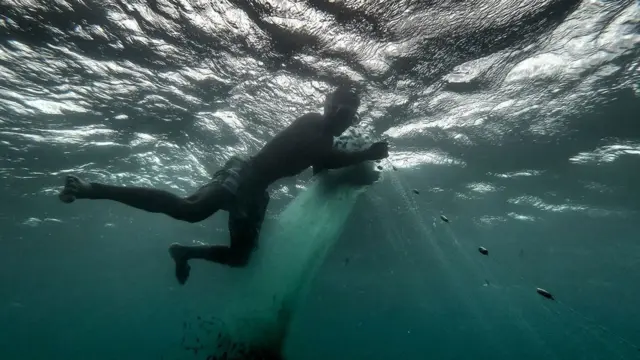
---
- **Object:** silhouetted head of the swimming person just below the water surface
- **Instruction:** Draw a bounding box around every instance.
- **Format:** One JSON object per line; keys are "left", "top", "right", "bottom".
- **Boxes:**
{"left": 324, "top": 86, "right": 360, "bottom": 136}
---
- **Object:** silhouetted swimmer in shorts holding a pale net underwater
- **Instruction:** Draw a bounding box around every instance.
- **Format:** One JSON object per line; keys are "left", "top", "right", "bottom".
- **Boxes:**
{"left": 59, "top": 87, "right": 389, "bottom": 284}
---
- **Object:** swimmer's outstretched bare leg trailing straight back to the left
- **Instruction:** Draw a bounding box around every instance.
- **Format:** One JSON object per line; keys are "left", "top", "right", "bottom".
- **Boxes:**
{"left": 59, "top": 176, "right": 229, "bottom": 222}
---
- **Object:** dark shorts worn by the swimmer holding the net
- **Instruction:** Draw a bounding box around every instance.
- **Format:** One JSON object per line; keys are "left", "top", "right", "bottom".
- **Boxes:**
{"left": 206, "top": 156, "right": 270, "bottom": 248}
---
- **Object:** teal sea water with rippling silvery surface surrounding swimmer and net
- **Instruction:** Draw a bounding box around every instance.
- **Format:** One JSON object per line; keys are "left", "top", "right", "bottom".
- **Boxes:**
{"left": 0, "top": 0, "right": 640, "bottom": 360}
